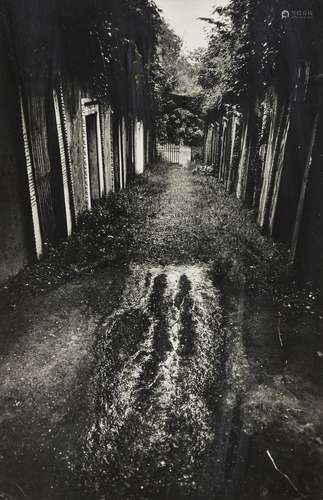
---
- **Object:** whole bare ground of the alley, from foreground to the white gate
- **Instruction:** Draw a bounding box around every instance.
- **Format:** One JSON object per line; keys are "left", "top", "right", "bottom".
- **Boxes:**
{"left": 0, "top": 166, "right": 323, "bottom": 500}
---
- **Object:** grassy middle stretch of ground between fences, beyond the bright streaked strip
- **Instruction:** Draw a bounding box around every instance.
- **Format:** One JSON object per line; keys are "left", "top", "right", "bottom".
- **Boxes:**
{"left": 2, "top": 165, "right": 285, "bottom": 297}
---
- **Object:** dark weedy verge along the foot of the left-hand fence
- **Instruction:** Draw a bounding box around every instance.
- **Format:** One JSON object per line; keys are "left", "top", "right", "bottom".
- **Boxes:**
{"left": 2, "top": 170, "right": 164, "bottom": 300}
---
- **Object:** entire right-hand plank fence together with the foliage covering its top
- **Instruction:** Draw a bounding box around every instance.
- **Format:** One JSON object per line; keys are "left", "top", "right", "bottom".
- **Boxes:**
{"left": 199, "top": 0, "right": 323, "bottom": 283}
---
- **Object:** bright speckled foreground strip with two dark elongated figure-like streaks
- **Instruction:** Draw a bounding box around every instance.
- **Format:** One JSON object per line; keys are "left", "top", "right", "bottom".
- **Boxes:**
{"left": 85, "top": 266, "right": 224, "bottom": 499}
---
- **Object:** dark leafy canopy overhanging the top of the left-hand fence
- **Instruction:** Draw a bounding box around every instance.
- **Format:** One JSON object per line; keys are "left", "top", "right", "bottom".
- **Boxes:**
{"left": 0, "top": 0, "right": 159, "bottom": 108}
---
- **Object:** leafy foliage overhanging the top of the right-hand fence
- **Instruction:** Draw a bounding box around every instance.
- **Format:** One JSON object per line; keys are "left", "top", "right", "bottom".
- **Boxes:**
{"left": 199, "top": 0, "right": 318, "bottom": 109}
